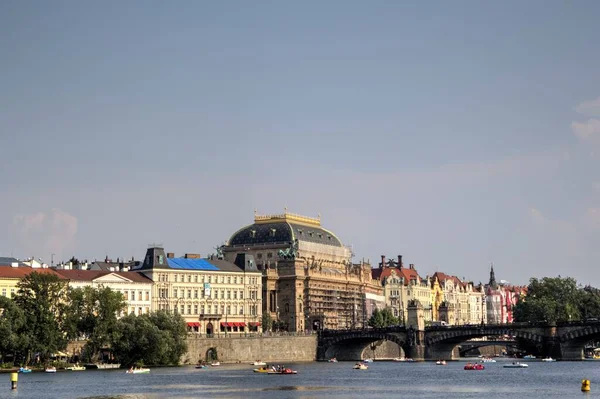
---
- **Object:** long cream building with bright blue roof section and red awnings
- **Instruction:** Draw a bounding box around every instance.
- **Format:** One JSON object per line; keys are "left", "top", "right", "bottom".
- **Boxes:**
{"left": 134, "top": 246, "right": 262, "bottom": 336}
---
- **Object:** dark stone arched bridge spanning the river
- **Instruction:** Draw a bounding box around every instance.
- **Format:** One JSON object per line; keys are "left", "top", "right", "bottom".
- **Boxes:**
{"left": 317, "top": 322, "right": 600, "bottom": 360}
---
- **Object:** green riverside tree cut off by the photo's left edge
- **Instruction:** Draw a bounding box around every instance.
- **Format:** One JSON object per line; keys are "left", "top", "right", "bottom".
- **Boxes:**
{"left": 0, "top": 296, "right": 25, "bottom": 363}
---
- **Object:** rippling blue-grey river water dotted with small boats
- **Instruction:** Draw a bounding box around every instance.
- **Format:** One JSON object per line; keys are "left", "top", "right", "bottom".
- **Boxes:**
{"left": 0, "top": 360, "right": 600, "bottom": 399}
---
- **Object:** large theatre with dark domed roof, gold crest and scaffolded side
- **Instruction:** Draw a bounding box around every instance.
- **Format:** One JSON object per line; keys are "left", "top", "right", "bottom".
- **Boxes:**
{"left": 220, "top": 209, "right": 384, "bottom": 331}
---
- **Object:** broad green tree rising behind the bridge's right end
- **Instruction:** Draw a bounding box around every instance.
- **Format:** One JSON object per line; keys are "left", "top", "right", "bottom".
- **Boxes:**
{"left": 514, "top": 276, "right": 581, "bottom": 322}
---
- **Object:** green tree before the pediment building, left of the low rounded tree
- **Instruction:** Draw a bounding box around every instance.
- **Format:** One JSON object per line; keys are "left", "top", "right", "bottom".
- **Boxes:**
{"left": 68, "top": 286, "right": 127, "bottom": 361}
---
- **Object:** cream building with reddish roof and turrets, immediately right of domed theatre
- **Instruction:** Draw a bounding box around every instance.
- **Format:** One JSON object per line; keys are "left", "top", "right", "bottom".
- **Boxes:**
{"left": 372, "top": 255, "right": 434, "bottom": 324}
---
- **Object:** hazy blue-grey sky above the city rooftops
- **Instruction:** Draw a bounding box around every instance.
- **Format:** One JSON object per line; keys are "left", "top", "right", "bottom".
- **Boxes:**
{"left": 0, "top": 0, "right": 600, "bottom": 287}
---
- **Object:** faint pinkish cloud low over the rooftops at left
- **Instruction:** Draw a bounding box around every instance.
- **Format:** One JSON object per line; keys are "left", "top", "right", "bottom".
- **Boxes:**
{"left": 13, "top": 209, "right": 78, "bottom": 259}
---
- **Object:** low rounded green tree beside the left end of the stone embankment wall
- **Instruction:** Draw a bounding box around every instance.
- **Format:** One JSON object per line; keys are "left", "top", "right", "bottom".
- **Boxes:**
{"left": 111, "top": 311, "right": 187, "bottom": 366}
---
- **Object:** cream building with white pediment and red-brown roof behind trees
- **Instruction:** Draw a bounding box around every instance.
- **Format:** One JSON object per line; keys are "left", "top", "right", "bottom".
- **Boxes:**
{"left": 56, "top": 269, "right": 153, "bottom": 316}
